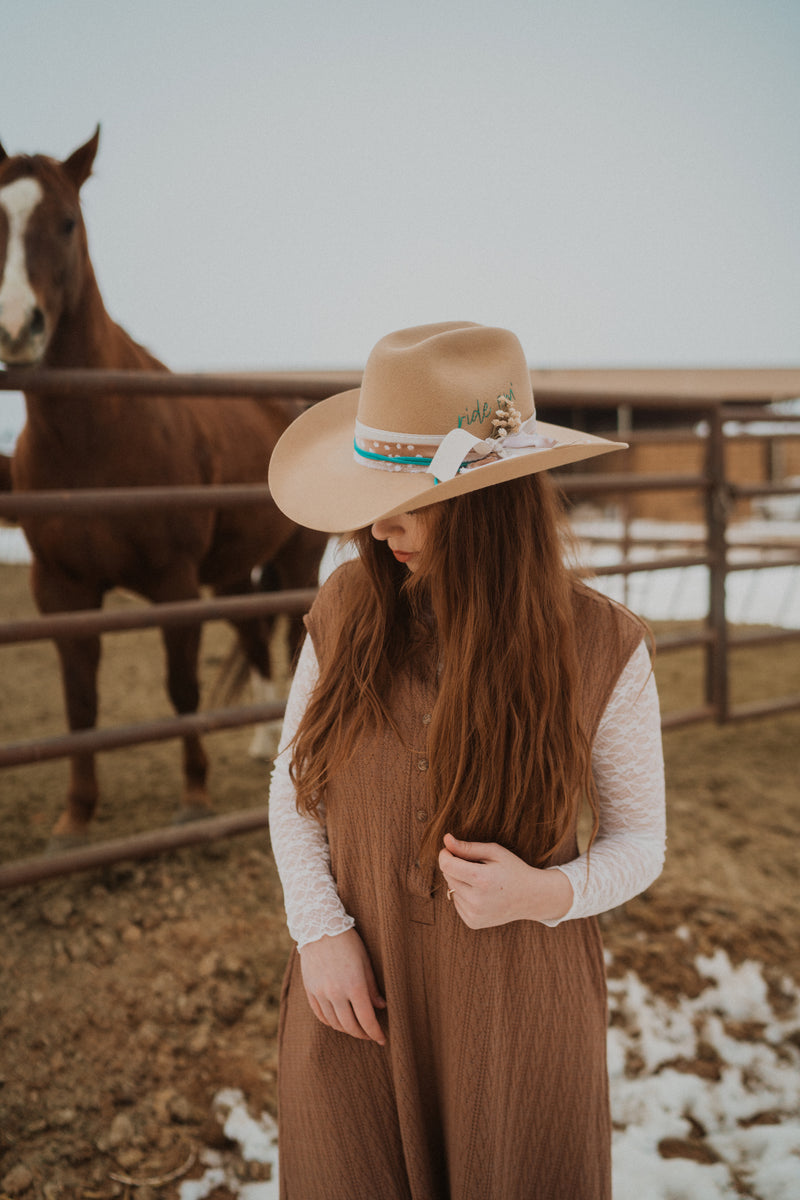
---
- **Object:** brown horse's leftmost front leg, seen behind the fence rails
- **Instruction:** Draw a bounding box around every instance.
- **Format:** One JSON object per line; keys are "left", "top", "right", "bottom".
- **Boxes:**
{"left": 31, "top": 559, "right": 103, "bottom": 851}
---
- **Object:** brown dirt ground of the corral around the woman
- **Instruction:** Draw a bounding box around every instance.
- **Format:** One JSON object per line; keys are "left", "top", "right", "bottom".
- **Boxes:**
{"left": 0, "top": 565, "right": 800, "bottom": 1200}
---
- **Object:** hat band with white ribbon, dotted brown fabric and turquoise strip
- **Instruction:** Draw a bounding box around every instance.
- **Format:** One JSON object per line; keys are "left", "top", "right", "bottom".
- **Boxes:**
{"left": 353, "top": 415, "right": 557, "bottom": 484}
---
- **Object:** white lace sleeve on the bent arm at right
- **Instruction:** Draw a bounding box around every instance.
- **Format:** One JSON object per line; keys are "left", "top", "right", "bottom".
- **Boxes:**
{"left": 545, "top": 642, "right": 666, "bottom": 925}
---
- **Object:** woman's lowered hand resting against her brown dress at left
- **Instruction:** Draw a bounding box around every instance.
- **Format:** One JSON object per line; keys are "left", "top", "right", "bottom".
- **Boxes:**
{"left": 300, "top": 929, "right": 386, "bottom": 1046}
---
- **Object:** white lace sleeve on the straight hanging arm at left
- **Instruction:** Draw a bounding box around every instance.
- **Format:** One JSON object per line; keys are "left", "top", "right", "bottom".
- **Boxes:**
{"left": 270, "top": 637, "right": 355, "bottom": 947}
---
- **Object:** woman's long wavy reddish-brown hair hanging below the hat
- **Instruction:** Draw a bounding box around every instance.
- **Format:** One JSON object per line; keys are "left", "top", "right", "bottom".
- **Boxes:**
{"left": 291, "top": 468, "right": 597, "bottom": 865}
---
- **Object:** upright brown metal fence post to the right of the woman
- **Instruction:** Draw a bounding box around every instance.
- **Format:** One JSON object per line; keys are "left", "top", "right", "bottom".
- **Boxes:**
{"left": 705, "top": 404, "right": 729, "bottom": 725}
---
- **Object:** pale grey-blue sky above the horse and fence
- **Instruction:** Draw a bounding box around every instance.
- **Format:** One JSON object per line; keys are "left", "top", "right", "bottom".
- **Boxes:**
{"left": 0, "top": 0, "right": 800, "bottom": 441}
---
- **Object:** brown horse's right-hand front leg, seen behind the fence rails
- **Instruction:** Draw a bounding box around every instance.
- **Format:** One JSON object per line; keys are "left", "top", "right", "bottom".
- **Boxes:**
{"left": 148, "top": 570, "right": 212, "bottom": 822}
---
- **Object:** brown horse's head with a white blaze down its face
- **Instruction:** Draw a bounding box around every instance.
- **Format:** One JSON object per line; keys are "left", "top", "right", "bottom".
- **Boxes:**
{"left": 0, "top": 126, "right": 100, "bottom": 366}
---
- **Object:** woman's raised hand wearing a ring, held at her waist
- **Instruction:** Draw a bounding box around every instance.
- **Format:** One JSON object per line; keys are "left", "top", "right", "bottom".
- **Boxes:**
{"left": 439, "top": 833, "right": 573, "bottom": 929}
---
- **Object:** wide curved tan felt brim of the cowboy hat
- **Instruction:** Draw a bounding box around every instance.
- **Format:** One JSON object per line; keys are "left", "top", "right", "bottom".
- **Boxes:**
{"left": 269, "top": 388, "right": 627, "bottom": 533}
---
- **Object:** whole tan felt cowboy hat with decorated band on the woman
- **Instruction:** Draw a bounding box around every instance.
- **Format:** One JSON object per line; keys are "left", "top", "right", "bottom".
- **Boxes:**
{"left": 270, "top": 322, "right": 625, "bottom": 533}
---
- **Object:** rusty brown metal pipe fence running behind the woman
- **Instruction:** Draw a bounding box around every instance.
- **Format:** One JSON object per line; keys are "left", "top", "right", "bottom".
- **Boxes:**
{"left": 0, "top": 368, "right": 800, "bottom": 888}
